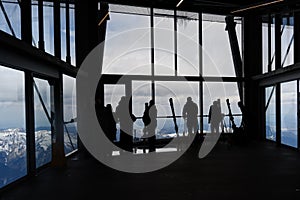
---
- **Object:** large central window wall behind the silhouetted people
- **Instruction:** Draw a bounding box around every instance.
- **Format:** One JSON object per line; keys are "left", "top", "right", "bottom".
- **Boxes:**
{"left": 102, "top": 6, "right": 242, "bottom": 142}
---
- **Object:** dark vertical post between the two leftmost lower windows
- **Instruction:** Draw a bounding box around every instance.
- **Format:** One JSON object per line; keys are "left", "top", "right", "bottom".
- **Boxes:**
{"left": 25, "top": 72, "right": 36, "bottom": 176}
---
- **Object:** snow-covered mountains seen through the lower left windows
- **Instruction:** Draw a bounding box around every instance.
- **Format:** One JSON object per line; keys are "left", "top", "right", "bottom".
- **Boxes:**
{"left": 0, "top": 128, "right": 51, "bottom": 187}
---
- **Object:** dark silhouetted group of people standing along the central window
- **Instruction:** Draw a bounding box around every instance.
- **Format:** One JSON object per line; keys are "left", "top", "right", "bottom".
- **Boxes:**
{"left": 96, "top": 96, "right": 223, "bottom": 152}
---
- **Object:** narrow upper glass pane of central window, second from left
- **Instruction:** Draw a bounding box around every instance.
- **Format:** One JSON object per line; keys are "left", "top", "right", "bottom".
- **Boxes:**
{"left": 154, "top": 9, "right": 175, "bottom": 75}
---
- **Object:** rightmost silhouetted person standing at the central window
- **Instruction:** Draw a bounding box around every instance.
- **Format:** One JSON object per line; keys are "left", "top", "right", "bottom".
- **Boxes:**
{"left": 208, "top": 101, "right": 223, "bottom": 133}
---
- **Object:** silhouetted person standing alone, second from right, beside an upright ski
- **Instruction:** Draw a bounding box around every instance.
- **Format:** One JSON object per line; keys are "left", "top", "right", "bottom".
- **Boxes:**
{"left": 182, "top": 97, "right": 198, "bottom": 135}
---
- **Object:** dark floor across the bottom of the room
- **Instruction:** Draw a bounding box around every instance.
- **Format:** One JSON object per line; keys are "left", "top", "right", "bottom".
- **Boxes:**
{"left": 0, "top": 138, "right": 300, "bottom": 200}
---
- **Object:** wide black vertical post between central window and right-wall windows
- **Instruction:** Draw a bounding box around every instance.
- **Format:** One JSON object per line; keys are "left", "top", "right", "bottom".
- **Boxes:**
{"left": 243, "top": 14, "right": 264, "bottom": 139}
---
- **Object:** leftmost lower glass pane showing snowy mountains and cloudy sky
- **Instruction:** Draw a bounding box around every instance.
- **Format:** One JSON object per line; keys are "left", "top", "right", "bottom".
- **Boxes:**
{"left": 0, "top": 66, "right": 27, "bottom": 188}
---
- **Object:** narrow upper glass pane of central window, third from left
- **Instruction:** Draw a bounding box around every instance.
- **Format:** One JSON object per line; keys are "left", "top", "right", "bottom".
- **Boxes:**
{"left": 177, "top": 13, "right": 200, "bottom": 76}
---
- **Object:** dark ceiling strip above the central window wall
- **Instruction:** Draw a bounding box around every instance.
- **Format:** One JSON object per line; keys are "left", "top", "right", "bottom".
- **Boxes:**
{"left": 100, "top": 0, "right": 300, "bottom": 15}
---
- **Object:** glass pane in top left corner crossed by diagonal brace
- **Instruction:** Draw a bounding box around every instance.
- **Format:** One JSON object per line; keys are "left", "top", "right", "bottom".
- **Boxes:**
{"left": 0, "top": 0, "right": 21, "bottom": 39}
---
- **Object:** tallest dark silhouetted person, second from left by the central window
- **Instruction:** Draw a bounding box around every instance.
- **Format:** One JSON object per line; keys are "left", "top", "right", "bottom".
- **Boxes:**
{"left": 116, "top": 96, "right": 136, "bottom": 152}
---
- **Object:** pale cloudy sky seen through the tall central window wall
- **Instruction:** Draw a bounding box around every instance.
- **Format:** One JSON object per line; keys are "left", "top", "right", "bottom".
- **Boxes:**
{"left": 102, "top": 13, "right": 240, "bottom": 115}
